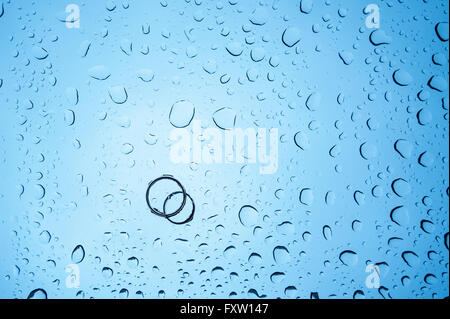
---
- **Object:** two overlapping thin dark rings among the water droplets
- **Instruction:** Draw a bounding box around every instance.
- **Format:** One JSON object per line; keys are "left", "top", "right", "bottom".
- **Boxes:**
{"left": 146, "top": 175, "right": 195, "bottom": 225}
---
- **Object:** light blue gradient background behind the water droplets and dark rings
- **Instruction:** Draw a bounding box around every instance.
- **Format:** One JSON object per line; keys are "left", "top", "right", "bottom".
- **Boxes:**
{"left": 0, "top": 0, "right": 449, "bottom": 298}
